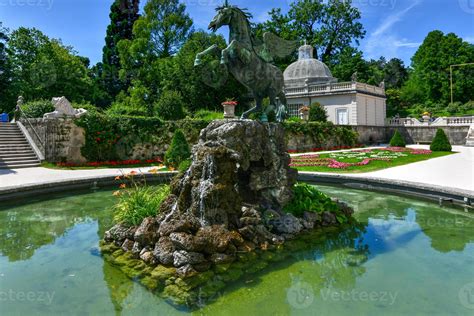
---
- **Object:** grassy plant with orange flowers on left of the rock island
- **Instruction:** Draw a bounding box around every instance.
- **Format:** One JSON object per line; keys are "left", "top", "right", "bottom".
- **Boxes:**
{"left": 113, "top": 185, "right": 170, "bottom": 226}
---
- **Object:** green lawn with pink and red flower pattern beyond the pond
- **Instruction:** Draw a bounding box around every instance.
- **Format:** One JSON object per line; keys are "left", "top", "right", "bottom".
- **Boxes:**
{"left": 291, "top": 148, "right": 454, "bottom": 173}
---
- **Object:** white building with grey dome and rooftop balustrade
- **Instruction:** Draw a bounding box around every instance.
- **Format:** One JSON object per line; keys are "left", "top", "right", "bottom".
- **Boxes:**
{"left": 284, "top": 45, "right": 386, "bottom": 126}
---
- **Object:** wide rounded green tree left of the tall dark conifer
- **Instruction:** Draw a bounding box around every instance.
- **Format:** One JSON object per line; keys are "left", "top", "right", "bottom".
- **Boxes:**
{"left": 8, "top": 27, "right": 92, "bottom": 102}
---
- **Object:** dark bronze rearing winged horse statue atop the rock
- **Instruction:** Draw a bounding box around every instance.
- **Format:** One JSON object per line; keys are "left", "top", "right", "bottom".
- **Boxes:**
{"left": 194, "top": 0, "right": 298, "bottom": 122}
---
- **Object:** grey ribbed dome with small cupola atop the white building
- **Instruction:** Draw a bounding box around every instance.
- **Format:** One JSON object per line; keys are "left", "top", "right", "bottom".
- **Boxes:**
{"left": 283, "top": 45, "right": 337, "bottom": 87}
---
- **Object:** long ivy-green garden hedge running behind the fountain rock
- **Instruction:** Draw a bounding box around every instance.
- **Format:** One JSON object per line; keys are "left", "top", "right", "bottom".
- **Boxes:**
{"left": 76, "top": 112, "right": 357, "bottom": 161}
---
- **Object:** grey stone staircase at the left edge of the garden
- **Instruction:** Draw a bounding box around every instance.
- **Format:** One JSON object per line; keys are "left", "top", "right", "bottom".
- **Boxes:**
{"left": 0, "top": 123, "right": 40, "bottom": 169}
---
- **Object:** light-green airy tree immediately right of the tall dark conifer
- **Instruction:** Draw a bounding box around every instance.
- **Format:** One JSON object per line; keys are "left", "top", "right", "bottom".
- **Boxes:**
{"left": 118, "top": 0, "right": 193, "bottom": 115}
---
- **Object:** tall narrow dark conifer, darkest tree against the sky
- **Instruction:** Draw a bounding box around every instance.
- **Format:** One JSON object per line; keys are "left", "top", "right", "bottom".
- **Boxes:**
{"left": 96, "top": 0, "right": 139, "bottom": 103}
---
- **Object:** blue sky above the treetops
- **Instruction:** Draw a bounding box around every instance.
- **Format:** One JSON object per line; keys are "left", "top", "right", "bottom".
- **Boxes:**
{"left": 0, "top": 0, "right": 474, "bottom": 64}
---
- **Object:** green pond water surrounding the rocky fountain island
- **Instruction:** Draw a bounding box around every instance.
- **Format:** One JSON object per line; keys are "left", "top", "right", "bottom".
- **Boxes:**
{"left": 0, "top": 186, "right": 474, "bottom": 316}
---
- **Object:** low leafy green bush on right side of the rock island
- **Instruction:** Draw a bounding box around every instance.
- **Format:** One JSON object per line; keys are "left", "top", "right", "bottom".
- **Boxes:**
{"left": 284, "top": 183, "right": 339, "bottom": 217}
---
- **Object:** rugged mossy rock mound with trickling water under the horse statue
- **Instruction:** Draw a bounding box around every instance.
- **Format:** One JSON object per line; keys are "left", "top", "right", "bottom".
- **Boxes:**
{"left": 102, "top": 120, "right": 352, "bottom": 304}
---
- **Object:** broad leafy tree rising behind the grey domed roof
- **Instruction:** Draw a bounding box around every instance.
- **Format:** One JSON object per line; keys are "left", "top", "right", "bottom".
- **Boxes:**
{"left": 257, "top": 0, "right": 365, "bottom": 63}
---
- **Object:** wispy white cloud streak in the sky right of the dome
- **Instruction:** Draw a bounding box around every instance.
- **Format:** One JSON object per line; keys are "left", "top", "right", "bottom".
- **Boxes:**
{"left": 364, "top": 0, "right": 422, "bottom": 59}
